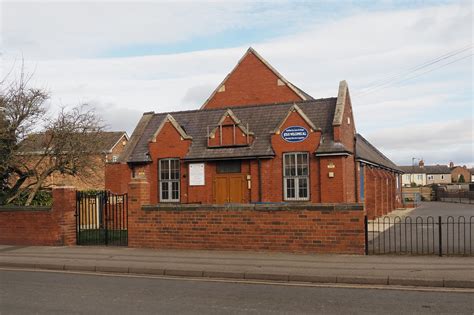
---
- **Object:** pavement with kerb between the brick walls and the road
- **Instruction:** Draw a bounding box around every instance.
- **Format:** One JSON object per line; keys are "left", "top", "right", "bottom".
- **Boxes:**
{"left": 0, "top": 245, "right": 474, "bottom": 289}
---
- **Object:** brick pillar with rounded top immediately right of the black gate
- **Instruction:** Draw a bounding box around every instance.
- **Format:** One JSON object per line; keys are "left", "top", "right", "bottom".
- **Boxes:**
{"left": 128, "top": 178, "right": 150, "bottom": 247}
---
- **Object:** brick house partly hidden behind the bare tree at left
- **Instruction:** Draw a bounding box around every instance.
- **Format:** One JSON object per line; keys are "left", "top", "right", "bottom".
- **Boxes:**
{"left": 18, "top": 131, "right": 128, "bottom": 190}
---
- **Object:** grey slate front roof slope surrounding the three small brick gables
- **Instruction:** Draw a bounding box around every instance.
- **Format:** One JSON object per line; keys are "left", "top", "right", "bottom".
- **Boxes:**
{"left": 123, "top": 98, "right": 336, "bottom": 163}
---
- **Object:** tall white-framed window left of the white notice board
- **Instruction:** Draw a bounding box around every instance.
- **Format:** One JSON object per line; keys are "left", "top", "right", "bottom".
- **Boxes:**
{"left": 158, "top": 159, "right": 180, "bottom": 202}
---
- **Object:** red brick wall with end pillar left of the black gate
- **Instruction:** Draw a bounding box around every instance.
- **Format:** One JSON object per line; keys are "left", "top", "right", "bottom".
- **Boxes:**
{"left": 0, "top": 187, "right": 76, "bottom": 246}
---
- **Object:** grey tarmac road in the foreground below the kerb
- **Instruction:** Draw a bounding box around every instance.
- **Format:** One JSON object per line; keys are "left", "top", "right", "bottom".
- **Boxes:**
{"left": 0, "top": 270, "right": 474, "bottom": 314}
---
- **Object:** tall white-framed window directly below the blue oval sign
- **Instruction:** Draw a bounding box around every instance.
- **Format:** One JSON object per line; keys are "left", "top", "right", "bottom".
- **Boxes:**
{"left": 283, "top": 153, "right": 309, "bottom": 200}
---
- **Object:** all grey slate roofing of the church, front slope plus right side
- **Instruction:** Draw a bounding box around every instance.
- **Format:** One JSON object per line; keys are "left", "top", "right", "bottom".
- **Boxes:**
{"left": 121, "top": 97, "right": 401, "bottom": 172}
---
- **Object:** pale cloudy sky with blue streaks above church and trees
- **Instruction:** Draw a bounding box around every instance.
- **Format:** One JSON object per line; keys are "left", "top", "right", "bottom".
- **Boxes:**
{"left": 0, "top": 0, "right": 474, "bottom": 166}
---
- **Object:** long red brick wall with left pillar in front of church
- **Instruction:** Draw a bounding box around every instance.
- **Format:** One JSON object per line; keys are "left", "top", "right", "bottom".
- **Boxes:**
{"left": 128, "top": 180, "right": 364, "bottom": 254}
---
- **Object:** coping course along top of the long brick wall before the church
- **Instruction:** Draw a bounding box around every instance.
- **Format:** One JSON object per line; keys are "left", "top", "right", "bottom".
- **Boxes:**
{"left": 142, "top": 203, "right": 364, "bottom": 211}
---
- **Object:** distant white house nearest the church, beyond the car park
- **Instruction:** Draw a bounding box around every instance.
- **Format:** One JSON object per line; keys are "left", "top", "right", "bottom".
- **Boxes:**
{"left": 400, "top": 160, "right": 451, "bottom": 187}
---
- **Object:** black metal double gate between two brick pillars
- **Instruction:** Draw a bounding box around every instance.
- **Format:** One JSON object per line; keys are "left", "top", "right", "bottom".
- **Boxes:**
{"left": 75, "top": 191, "right": 128, "bottom": 246}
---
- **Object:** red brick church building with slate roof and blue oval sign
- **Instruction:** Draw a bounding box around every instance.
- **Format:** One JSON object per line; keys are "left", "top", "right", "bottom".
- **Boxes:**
{"left": 106, "top": 48, "right": 401, "bottom": 217}
